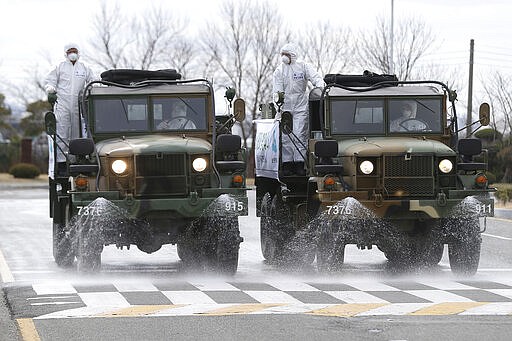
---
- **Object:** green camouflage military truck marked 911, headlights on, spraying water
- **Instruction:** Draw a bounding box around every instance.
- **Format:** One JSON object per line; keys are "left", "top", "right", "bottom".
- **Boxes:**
{"left": 256, "top": 73, "right": 494, "bottom": 275}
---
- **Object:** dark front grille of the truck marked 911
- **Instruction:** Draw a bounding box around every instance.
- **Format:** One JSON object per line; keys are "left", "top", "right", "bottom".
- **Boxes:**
{"left": 383, "top": 155, "right": 434, "bottom": 197}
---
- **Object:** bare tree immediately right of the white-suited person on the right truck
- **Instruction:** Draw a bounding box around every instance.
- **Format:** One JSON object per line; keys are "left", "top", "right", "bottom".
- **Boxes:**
{"left": 294, "top": 21, "right": 355, "bottom": 75}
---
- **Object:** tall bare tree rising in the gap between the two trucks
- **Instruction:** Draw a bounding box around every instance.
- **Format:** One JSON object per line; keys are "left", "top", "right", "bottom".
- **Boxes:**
{"left": 201, "top": 0, "right": 290, "bottom": 144}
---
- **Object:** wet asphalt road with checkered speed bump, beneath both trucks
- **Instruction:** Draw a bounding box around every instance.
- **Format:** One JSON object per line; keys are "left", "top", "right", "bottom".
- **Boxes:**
{"left": 0, "top": 188, "right": 512, "bottom": 340}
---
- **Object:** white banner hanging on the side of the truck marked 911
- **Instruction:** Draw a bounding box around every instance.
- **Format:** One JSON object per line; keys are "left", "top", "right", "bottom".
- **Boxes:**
{"left": 254, "top": 119, "right": 279, "bottom": 179}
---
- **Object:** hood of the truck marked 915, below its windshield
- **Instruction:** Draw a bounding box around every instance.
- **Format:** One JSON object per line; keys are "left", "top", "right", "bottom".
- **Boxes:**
{"left": 96, "top": 135, "right": 212, "bottom": 157}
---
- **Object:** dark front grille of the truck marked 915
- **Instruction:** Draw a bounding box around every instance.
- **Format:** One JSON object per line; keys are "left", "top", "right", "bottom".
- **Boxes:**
{"left": 135, "top": 153, "right": 188, "bottom": 196}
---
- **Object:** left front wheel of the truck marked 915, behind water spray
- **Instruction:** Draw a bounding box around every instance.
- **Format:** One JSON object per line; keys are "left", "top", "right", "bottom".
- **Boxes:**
{"left": 76, "top": 229, "right": 103, "bottom": 272}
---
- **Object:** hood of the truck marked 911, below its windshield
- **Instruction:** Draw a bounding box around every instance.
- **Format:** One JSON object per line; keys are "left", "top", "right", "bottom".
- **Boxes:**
{"left": 339, "top": 137, "right": 455, "bottom": 156}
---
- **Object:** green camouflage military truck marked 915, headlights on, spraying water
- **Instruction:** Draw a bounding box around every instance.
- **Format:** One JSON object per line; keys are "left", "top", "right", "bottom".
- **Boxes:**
{"left": 45, "top": 70, "right": 247, "bottom": 274}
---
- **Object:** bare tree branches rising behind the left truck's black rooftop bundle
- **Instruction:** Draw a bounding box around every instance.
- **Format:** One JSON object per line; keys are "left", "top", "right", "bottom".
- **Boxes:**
{"left": 88, "top": 2, "right": 194, "bottom": 74}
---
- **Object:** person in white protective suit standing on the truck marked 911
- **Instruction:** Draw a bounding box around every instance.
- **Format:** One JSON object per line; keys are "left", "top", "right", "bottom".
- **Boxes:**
{"left": 272, "top": 43, "right": 324, "bottom": 175}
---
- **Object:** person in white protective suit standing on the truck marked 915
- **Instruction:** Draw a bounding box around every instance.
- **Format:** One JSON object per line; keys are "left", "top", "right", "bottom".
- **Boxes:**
{"left": 45, "top": 43, "right": 94, "bottom": 178}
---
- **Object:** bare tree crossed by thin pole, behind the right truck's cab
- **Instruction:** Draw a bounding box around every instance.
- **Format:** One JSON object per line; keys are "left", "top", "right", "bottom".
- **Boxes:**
{"left": 357, "top": 17, "right": 435, "bottom": 80}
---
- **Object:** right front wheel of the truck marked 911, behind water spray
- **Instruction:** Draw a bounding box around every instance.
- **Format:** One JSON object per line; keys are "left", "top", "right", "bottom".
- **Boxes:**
{"left": 448, "top": 219, "right": 482, "bottom": 276}
